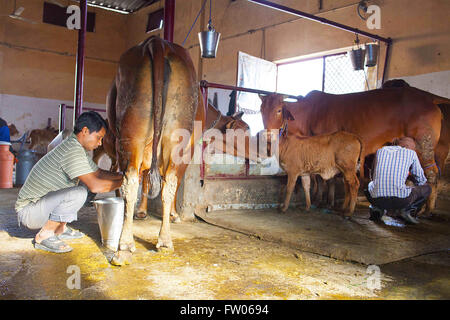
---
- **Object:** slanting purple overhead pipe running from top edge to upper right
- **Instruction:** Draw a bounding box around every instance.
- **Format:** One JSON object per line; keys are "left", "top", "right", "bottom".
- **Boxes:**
{"left": 248, "top": 0, "right": 392, "bottom": 43}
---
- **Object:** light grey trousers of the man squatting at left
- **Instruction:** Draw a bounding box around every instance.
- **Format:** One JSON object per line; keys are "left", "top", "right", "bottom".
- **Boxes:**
{"left": 17, "top": 186, "right": 87, "bottom": 229}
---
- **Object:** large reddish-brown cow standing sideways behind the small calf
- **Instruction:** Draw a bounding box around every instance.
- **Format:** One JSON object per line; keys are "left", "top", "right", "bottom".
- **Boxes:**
{"left": 261, "top": 88, "right": 442, "bottom": 213}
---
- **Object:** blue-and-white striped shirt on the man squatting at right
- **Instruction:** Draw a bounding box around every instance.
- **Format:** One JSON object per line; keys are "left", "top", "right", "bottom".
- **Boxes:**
{"left": 369, "top": 146, "right": 427, "bottom": 198}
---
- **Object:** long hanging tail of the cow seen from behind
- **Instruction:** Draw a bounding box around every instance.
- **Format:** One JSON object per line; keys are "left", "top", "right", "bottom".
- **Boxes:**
{"left": 147, "top": 40, "right": 170, "bottom": 199}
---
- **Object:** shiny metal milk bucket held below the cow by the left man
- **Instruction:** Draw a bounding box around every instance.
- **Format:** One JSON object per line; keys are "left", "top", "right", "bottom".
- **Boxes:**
{"left": 93, "top": 197, "right": 125, "bottom": 251}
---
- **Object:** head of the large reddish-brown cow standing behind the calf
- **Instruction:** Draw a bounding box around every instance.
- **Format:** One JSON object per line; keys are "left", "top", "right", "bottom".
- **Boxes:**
{"left": 259, "top": 93, "right": 285, "bottom": 129}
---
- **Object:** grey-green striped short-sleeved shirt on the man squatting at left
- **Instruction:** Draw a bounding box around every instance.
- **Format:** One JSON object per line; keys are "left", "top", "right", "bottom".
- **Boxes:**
{"left": 15, "top": 133, "right": 98, "bottom": 212}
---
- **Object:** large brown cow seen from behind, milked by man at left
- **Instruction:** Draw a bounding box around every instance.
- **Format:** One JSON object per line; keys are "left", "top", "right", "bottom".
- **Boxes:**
{"left": 106, "top": 36, "right": 201, "bottom": 265}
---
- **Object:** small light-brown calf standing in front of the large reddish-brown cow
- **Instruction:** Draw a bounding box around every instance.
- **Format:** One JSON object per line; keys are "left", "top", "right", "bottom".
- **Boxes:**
{"left": 266, "top": 107, "right": 363, "bottom": 217}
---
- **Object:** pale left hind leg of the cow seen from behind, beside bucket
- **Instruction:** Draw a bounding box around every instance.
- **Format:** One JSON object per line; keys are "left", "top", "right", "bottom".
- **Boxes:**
{"left": 111, "top": 163, "right": 139, "bottom": 266}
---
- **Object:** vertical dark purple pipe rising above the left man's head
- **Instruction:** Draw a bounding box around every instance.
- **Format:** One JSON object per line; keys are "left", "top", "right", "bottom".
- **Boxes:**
{"left": 73, "top": 0, "right": 87, "bottom": 124}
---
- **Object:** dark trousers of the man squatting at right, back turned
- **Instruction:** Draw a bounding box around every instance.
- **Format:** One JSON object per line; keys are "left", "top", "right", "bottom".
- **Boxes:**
{"left": 365, "top": 184, "right": 431, "bottom": 210}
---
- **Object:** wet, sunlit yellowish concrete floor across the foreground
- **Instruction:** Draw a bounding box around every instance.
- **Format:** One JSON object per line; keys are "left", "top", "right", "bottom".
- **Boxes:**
{"left": 0, "top": 182, "right": 450, "bottom": 300}
